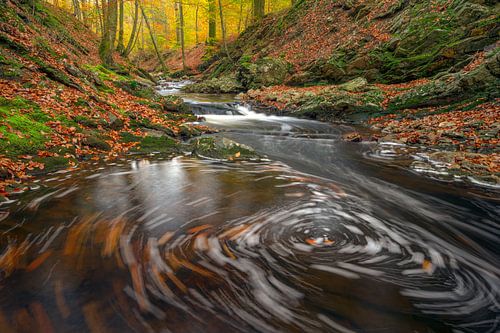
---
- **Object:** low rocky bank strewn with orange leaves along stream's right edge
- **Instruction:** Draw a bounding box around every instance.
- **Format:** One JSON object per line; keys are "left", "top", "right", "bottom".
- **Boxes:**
{"left": 240, "top": 66, "right": 500, "bottom": 185}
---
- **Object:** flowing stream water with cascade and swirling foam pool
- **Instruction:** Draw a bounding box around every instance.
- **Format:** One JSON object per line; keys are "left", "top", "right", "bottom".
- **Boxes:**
{"left": 0, "top": 81, "right": 500, "bottom": 332}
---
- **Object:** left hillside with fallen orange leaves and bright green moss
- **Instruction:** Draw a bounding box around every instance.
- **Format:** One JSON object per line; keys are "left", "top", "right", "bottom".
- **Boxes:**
{"left": 0, "top": 1, "right": 204, "bottom": 195}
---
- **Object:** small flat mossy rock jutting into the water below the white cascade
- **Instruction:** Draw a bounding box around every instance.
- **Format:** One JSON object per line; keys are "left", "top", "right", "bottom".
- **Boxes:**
{"left": 192, "top": 137, "right": 259, "bottom": 161}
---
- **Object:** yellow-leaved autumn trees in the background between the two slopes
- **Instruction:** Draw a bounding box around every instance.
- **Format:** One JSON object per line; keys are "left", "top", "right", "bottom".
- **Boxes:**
{"left": 57, "top": 0, "right": 292, "bottom": 66}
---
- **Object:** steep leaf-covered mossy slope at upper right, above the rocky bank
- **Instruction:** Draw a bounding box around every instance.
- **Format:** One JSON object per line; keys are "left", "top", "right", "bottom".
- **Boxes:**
{"left": 204, "top": 0, "right": 500, "bottom": 84}
